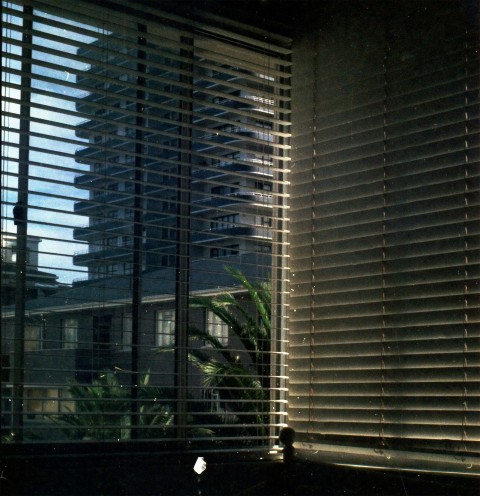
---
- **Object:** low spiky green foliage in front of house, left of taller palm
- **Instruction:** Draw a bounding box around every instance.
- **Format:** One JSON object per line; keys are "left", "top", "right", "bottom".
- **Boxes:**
{"left": 50, "top": 371, "right": 173, "bottom": 441}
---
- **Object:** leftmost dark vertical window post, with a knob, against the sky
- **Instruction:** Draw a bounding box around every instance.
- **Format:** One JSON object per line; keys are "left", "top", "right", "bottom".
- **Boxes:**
{"left": 12, "top": 6, "right": 33, "bottom": 442}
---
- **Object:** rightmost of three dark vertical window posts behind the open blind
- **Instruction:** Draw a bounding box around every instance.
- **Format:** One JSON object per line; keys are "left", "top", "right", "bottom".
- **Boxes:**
{"left": 175, "top": 37, "right": 193, "bottom": 444}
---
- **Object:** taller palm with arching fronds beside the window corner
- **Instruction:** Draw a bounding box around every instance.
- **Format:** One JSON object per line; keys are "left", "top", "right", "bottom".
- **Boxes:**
{"left": 189, "top": 267, "right": 272, "bottom": 425}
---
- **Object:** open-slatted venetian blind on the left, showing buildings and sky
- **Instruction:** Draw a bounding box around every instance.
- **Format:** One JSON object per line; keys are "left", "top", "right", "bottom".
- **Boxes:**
{"left": 2, "top": 0, "right": 290, "bottom": 450}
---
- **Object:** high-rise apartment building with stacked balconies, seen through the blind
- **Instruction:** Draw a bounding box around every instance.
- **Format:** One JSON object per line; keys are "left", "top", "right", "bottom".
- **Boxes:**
{"left": 74, "top": 33, "right": 284, "bottom": 279}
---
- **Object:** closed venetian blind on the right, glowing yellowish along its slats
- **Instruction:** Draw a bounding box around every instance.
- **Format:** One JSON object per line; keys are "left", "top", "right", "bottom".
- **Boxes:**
{"left": 289, "top": 2, "right": 480, "bottom": 474}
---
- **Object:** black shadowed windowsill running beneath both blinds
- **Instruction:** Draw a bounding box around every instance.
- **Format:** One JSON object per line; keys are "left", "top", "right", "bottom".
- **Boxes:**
{"left": 0, "top": 443, "right": 478, "bottom": 496}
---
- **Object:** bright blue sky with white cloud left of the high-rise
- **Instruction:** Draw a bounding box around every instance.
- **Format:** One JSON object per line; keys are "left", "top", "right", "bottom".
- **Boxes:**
{"left": 2, "top": 8, "right": 99, "bottom": 283}
